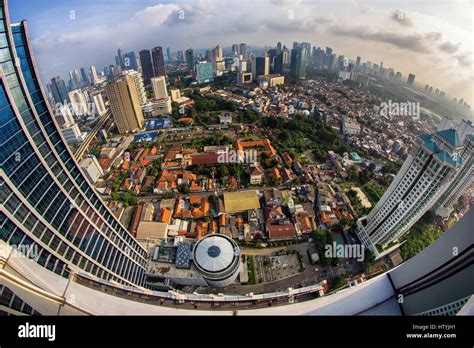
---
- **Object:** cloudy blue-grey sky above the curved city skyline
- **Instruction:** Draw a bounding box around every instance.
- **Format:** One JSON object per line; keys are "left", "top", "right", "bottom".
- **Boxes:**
{"left": 9, "top": 0, "right": 474, "bottom": 106}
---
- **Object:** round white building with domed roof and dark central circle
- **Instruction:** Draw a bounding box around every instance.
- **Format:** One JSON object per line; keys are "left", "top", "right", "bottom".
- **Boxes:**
{"left": 193, "top": 234, "right": 240, "bottom": 287}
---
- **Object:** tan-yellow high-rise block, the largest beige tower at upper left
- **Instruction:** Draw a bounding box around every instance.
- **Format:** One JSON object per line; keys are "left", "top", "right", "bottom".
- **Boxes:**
{"left": 105, "top": 74, "right": 145, "bottom": 134}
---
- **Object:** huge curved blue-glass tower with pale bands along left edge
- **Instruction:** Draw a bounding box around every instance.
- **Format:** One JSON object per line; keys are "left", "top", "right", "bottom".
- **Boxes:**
{"left": 0, "top": 14, "right": 146, "bottom": 285}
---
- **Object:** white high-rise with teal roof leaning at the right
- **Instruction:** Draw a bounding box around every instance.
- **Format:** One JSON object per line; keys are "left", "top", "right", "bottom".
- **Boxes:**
{"left": 357, "top": 129, "right": 472, "bottom": 255}
